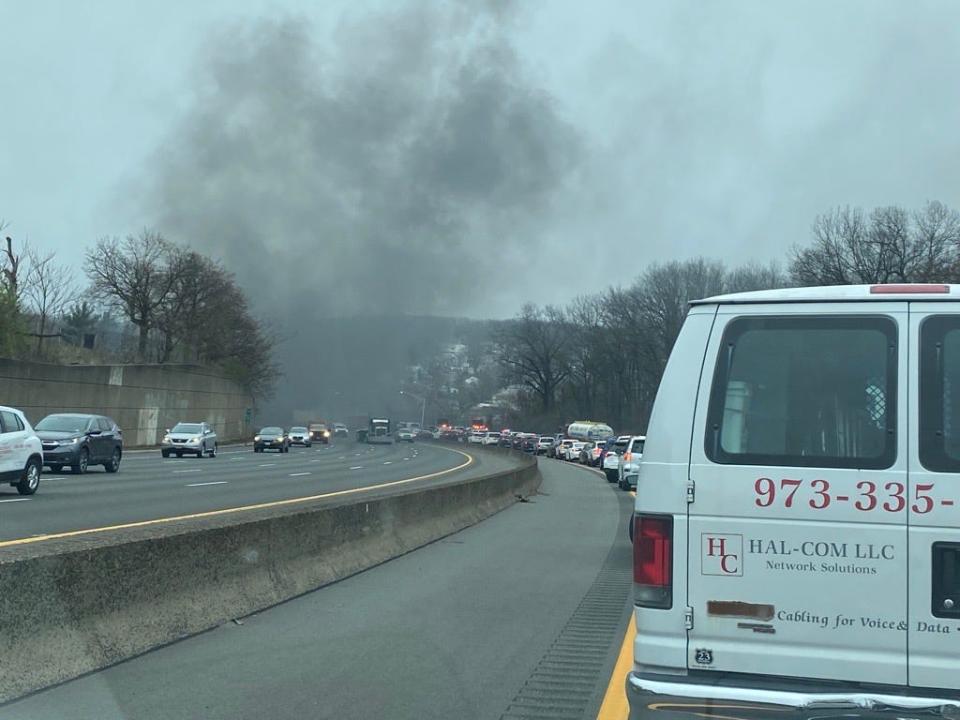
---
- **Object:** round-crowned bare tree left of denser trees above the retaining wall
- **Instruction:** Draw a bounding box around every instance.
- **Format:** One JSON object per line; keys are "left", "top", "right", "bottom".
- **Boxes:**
{"left": 84, "top": 230, "right": 176, "bottom": 358}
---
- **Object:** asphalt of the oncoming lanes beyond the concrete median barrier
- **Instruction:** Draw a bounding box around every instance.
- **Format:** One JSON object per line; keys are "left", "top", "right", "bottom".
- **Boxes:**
{"left": 0, "top": 440, "right": 514, "bottom": 551}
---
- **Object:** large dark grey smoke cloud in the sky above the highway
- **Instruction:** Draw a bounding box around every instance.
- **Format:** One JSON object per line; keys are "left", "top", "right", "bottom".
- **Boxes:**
{"left": 145, "top": 3, "right": 580, "bottom": 317}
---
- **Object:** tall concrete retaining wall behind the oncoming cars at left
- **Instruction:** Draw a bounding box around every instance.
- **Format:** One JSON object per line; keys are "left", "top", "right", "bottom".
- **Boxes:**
{"left": 0, "top": 359, "right": 253, "bottom": 447}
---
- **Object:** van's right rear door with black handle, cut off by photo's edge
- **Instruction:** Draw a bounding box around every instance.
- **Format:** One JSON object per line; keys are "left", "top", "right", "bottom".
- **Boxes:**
{"left": 907, "top": 302, "right": 960, "bottom": 689}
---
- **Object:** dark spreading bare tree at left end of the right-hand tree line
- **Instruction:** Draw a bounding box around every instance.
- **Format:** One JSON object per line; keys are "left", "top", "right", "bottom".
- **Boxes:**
{"left": 495, "top": 304, "right": 569, "bottom": 413}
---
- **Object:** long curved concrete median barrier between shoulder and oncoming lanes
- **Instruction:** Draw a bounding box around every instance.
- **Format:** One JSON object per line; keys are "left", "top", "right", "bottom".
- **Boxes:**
{"left": 0, "top": 458, "right": 540, "bottom": 702}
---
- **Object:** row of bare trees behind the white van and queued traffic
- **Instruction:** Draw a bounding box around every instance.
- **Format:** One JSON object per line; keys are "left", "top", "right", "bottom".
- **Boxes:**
{"left": 495, "top": 202, "right": 960, "bottom": 432}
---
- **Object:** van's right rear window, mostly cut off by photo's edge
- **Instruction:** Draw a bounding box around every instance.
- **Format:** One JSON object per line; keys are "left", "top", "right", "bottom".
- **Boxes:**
{"left": 920, "top": 315, "right": 960, "bottom": 472}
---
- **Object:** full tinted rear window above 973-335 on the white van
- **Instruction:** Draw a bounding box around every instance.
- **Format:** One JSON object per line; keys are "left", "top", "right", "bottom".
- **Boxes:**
{"left": 705, "top": 315, "right": 897, "bottom": 469}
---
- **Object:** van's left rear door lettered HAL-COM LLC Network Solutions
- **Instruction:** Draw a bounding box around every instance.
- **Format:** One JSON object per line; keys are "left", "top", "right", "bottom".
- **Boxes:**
{"left": 687, "top": 303, "right": 907, "bottom": 684}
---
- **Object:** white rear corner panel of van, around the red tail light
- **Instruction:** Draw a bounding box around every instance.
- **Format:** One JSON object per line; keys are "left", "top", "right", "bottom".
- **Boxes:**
{"left": 634, "top": 307, "right": 716, "bottom": 673}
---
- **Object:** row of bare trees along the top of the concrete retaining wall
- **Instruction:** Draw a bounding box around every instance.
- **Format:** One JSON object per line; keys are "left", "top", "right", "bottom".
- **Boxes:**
{"left": 0, "top": 226, "right": 278, "bottom": 397}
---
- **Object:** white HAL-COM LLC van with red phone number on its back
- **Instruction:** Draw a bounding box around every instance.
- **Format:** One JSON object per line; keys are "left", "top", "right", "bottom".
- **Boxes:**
{"left": 627, "top": 285, "right": 960, "bottom": 718}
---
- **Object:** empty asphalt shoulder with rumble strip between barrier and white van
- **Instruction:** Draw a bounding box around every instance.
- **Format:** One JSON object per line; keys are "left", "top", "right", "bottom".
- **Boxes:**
{"left": 0, "top": 458, "right": 632, "bottom": 720}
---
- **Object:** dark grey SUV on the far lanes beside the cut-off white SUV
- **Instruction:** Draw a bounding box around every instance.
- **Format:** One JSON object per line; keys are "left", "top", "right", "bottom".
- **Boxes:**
{"left": 34, "top": 413, "right": 123, "bottom": 475}
